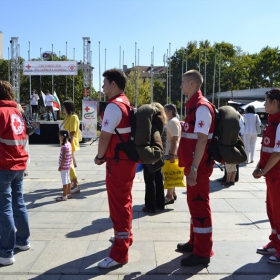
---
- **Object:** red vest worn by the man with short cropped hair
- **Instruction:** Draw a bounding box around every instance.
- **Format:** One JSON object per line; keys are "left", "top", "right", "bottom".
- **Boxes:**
{"left": 178, "top": 90, "right": 215, "bottom": 167}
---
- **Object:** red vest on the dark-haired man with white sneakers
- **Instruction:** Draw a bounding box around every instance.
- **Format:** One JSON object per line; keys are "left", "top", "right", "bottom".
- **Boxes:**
{"left": 101, "top": 93, "right": 131, "bottom": 159}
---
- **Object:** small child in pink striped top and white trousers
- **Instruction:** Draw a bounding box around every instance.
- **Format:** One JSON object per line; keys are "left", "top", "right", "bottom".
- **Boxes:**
{"left": 56, "top": 130, "right": 72, "bottom": 201}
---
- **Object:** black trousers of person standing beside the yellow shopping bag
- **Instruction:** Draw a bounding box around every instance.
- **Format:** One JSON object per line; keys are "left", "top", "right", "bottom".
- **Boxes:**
{"left": 143, "top": 164, "right": 165, "bottom": 210}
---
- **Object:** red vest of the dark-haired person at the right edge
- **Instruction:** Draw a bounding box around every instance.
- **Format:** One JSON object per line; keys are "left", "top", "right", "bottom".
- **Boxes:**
{"left": 260, "top": 112, "right": 280, "bottom": 178}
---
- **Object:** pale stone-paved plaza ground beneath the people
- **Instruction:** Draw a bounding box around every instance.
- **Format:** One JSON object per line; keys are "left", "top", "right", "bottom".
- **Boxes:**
{"left": 0, "top": 136, "right": 280, "bottom": 280}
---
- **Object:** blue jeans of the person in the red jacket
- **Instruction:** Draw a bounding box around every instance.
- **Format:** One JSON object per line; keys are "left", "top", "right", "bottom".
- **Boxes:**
{"left": 0, "top": 170, "right": 30, "bottom": 258}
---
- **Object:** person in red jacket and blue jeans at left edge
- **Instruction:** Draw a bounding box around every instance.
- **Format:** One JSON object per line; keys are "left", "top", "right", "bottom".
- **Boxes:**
{"left": 0, "top": 80, "right": 30, "bottom": 265}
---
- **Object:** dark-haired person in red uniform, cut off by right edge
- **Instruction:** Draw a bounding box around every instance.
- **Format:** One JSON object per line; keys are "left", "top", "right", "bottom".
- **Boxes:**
{"left": 253, "top": 88, "right": 280, "bottom": 264}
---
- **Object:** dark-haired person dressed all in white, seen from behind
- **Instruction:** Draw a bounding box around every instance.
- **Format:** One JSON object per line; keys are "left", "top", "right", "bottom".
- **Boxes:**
{"left": 244, "top": 105, "right": 261, "bottom": 163}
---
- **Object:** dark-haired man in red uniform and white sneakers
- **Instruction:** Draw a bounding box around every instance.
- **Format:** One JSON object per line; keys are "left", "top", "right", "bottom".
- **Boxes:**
{"left": 94, "top": 69, "right": 136, "bottom": 268}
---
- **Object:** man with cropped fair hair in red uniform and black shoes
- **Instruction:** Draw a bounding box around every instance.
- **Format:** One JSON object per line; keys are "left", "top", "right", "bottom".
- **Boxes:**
{"left": 177, "top": 70, "right": 215, "bottom": 266}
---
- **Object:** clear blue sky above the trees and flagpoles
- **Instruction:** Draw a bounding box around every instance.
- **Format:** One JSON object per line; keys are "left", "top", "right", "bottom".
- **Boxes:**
{"left": 0, "top": 0, "right": 280, "bottom": 90}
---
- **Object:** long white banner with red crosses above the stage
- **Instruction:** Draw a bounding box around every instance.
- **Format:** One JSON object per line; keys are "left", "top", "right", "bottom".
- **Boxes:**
{"left": 23, "top": 61, "right": 78, "bottom": 76}
